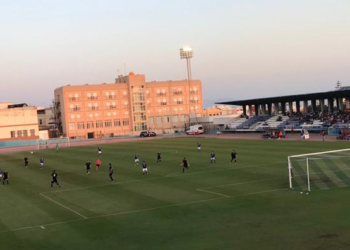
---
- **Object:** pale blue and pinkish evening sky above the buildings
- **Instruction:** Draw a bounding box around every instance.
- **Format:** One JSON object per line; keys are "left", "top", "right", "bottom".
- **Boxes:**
{"left": 0, "top": 0, "right": 350, "bottom": 107}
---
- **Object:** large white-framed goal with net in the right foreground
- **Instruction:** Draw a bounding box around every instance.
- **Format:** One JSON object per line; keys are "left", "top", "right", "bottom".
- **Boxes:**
{"left": 287, "top": 149, "right": 350, "bottom": 191}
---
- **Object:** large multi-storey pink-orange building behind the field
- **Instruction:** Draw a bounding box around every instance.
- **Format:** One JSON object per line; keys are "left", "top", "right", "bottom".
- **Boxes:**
{"left": 55, "top": 72, "right": 203, "bottom": 138}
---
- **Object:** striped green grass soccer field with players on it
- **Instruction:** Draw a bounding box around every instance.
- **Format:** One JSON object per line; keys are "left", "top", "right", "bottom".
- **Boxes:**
{"left": 0, "top": 137, "right": 350, "bottom": 250}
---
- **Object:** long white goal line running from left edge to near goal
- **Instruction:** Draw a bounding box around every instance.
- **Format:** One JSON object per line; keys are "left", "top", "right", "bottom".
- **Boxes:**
{"left": 0, "top": 188, "right": 289, "bottom": 233}
